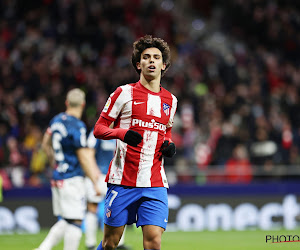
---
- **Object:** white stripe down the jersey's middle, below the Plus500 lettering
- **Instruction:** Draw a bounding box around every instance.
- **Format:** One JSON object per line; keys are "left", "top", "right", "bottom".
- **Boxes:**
{"left": 136, "top": 130, "right": 158, "bottom": 187}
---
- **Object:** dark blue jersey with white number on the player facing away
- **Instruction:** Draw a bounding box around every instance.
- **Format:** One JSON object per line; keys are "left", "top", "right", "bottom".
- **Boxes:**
{"left": 50, "top": 113, "right": 87, "bottom": 180}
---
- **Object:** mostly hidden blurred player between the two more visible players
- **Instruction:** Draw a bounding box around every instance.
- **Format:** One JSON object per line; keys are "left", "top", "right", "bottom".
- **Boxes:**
{"left": 85, "top": 131, "right": 130, "bottom": 250}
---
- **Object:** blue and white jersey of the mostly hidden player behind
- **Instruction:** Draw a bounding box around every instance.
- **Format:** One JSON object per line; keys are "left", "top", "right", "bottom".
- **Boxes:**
{"left": 87, "top": 130, "right": 116, "bottom": 174}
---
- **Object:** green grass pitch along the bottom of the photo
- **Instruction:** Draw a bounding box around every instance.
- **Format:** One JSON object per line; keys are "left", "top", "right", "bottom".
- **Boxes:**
{"left": 0, "top": 227, "right": 300, "bottom": 250}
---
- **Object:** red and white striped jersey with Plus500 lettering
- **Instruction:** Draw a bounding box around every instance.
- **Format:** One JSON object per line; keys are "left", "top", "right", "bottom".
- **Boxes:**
{"left": 101, "top": 82, "right": 177, "bottom": 187}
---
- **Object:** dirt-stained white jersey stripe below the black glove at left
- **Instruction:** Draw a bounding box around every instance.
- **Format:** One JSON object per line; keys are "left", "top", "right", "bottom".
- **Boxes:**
{"left": 109, "top": 140, "right": 127, "bottom": 184}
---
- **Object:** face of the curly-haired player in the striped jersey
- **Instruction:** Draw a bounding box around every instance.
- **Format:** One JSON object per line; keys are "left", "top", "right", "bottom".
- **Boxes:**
{"left": 137, "top": 48, "right": 166, "bottom": 80}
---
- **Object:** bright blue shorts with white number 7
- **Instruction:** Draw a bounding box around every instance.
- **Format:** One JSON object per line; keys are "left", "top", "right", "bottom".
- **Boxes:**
{"left": 104, "top": 184, "right": 169, "bottom": 229}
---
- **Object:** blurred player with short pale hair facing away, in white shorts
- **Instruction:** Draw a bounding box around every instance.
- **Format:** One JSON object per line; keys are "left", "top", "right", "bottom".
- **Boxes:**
{"left": 38, "top": 88, "right": 101, "bottom": 250}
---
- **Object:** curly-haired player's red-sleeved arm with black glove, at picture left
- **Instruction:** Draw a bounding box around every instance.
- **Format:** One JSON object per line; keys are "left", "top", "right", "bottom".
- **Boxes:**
{"left": 94, "top": 116, "right": 143, "bottom": 147}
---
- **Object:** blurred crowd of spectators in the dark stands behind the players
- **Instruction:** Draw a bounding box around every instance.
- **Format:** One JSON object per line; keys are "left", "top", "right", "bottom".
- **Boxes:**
{"left": 0, "top": 0, "right": 300, "bottom": 188}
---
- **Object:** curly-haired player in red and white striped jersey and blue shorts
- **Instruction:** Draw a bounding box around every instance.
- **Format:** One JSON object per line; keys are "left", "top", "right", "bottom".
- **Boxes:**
{"left": 94, "top": 35, "right": 177, "bottom": 250}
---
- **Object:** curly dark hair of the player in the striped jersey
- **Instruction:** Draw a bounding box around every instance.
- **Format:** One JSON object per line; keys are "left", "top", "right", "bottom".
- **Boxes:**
{"left": 131, "top": 35, "right": 171, "bottom": 76}
